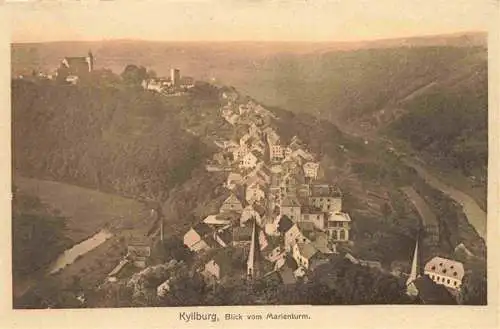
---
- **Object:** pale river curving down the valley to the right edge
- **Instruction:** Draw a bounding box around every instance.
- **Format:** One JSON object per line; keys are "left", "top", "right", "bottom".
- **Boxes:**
{"left": 403, "top": 159, "right": 487, "bottom": 242}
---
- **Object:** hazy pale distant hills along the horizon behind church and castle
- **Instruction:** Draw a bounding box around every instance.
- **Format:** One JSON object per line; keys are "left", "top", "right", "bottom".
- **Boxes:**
{"left": 11, "top": 33, "right": 486, "bottom": 80}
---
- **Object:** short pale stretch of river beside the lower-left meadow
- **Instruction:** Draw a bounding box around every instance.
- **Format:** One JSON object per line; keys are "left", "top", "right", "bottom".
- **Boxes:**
{"left": 49, "top": 229, "right": 113, "bottom": 274}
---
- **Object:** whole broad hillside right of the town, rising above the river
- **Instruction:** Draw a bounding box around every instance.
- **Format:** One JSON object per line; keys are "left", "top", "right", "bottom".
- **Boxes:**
{"left": 241, "top": 46, "right": 488, "bottom": 195}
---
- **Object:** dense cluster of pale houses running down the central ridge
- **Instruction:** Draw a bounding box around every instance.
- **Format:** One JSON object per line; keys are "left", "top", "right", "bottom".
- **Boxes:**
{"left": 184, "top": 90, "right": 351, "bottom": 283}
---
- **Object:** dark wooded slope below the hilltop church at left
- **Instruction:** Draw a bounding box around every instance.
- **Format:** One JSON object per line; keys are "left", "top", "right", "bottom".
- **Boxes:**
{"left": 12, "top": 80, "right": 211, "bottom": 200}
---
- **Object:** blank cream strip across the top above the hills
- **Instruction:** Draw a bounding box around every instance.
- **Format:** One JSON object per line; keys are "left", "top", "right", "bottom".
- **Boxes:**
{"left": 5, "top": 0, "right": 497, "bottom": 42}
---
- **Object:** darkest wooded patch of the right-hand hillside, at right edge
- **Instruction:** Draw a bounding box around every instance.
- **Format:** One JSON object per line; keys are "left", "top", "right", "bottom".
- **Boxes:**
{"left": 386, "top": 65, "right": 488, "bottom": 184}
